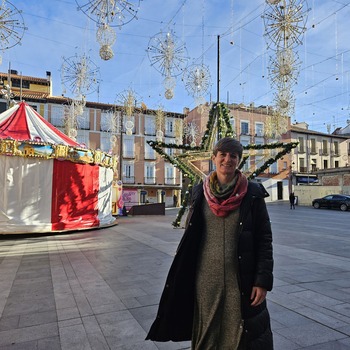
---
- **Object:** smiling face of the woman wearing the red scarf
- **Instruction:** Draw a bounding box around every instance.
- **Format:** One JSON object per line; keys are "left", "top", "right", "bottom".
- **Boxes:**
{"left": 212, "top": 151, "right": 239, "bottom": 184}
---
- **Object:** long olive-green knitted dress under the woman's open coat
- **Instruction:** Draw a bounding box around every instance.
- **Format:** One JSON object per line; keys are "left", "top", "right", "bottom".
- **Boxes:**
{"left": 192, "top": 201, "right": 243, "bottom": 350}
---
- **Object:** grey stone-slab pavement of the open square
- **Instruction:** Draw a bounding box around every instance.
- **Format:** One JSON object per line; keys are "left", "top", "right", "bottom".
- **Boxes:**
{"left": 0, "top": 202, "right": 350, "bottom": 350}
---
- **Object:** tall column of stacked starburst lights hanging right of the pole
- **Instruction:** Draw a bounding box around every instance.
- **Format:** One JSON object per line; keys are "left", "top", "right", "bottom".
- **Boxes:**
{"left": 262, "top": 0, "right": 309, "bottom": 136}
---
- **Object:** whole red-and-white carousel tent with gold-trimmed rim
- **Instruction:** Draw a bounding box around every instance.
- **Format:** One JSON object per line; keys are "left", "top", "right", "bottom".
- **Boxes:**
{"left": 0, "top": 102, "right": 116, "bottom": 234}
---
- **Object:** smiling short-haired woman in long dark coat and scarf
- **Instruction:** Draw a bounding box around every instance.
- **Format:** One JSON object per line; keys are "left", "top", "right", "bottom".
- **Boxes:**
{"left": 146, "top": 137, "right": 273, "bottom": 350}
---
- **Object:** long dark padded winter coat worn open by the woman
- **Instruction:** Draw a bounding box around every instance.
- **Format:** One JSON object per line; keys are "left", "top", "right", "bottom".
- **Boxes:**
{"left": 146, "top": 182, "right": 273, "bottom": 350}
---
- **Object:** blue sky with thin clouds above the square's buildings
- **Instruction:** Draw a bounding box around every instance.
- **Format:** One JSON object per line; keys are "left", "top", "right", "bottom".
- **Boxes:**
{"left": 0, "top": 0, "right": 350, "bottom": 133}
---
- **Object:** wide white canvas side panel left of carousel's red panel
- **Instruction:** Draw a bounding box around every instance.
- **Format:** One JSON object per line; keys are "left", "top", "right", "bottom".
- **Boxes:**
{"left": 0, "top": 155, "right": 53, "bottom": 233}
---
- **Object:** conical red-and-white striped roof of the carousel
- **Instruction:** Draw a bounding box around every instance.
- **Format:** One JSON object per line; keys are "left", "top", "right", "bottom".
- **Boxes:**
{"left": 0, "top": 102, "right": 78, "bottom": 146}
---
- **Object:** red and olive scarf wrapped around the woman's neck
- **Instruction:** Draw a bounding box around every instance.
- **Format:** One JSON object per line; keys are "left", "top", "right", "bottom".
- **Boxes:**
{"left": 203, "top": 170, "right": 248, "bottom": 217}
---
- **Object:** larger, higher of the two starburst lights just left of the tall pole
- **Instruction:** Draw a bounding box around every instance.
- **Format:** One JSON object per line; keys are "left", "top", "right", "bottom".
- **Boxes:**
{"left": 147, "top": 31, "right": 188, "bottom": 100}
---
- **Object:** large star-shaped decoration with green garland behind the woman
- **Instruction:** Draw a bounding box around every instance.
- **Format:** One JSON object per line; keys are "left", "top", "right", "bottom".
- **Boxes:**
{"left": 147, "top": 102, "right": 298, "bottom": 227}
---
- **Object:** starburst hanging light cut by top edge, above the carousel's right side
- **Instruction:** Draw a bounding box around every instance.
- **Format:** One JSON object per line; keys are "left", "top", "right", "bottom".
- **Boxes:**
{"left": 75, "top": 0, "right": 141, "bottom": 61}
